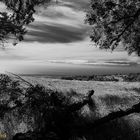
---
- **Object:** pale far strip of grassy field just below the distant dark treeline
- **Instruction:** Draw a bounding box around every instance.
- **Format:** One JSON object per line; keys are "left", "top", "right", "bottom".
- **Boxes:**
{"left": 21, "top": 77, "right": 140, "bottom": 96}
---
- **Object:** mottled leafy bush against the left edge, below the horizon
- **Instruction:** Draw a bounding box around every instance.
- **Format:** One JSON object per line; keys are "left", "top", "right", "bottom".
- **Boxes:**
{"left": 0, "top": 74, "right": 23, "bottom": 117}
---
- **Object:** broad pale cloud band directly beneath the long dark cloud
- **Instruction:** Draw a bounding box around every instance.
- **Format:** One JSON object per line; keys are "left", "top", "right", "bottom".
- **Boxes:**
{"left": 8, "top": 38, "right": 134, "bottom": 64}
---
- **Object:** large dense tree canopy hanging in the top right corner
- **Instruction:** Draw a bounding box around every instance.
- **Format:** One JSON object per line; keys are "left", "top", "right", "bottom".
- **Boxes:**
{"left": 86, "top": 0, "right": 140, "bottom": 56}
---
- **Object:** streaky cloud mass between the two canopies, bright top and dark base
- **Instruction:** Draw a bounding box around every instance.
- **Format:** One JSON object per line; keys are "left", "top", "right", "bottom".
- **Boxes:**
{"left": 25, "top": 1, "right": 89, "bottom": 43}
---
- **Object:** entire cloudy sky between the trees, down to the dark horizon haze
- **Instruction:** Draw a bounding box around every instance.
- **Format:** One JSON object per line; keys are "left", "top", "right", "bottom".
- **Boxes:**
{"left": 0, "top": 0, "right": 140, "bottom": 74}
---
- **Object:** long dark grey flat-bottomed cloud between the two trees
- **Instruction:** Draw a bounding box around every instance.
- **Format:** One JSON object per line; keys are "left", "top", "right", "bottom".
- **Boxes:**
{"left": 25, "top": 22, "right": 87, "bottom": 43}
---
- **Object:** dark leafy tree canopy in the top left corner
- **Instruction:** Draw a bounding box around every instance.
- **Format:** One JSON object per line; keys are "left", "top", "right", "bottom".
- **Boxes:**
{"left": 0, "top": 0, "right": 50, "bottom": 43}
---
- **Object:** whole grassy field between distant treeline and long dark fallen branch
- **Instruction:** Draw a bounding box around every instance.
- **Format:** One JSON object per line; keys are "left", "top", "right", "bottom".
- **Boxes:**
{"left": 21, "top": 76, "right": 140, "bottom": 119}
